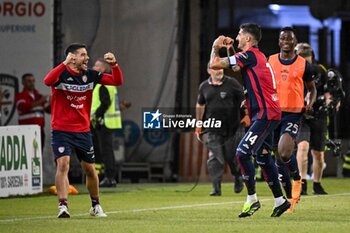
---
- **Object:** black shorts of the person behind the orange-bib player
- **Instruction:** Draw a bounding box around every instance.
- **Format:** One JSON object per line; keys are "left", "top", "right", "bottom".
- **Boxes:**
{"left": 297, "top": 117, "right": 327, "bottom": 151}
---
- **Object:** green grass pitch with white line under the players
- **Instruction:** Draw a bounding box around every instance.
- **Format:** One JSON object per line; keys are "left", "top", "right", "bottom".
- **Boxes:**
{"left": 0, "top": 178, "right": 350, "bottom": 233}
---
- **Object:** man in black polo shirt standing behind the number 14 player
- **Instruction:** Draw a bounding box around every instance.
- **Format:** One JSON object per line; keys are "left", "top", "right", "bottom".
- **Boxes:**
{"left": 196, "top": 66, "right": 244, "bottom": 196}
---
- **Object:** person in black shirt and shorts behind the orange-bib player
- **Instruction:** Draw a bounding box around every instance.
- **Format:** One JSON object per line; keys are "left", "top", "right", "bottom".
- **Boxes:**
{"left": 295, "top": 43, "right": 331, "bottom": 195}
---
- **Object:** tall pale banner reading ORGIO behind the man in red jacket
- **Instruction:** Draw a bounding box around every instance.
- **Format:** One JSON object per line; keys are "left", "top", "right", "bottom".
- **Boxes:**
{"left": 0, "top": 0, "right": 53, "bottom": 125}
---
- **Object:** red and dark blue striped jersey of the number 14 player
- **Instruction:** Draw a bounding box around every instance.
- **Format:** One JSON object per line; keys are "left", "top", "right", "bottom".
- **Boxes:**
{"left": 229, "top": 47, "right": 281, "bottom": 121}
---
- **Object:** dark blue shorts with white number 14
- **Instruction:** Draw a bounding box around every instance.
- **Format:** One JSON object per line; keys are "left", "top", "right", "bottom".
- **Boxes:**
{"left": 236, "top": 120, "right": 280, "bottom": 155}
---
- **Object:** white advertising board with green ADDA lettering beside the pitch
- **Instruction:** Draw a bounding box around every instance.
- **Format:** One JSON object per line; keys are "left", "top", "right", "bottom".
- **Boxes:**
{"left": 0, "top": 125, "right": 43, "bottom": 197}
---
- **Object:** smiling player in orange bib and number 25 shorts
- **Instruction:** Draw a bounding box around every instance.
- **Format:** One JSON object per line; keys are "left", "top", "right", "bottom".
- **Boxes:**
{"left": 269, "top": 27, "right": 316, "bottom": 212}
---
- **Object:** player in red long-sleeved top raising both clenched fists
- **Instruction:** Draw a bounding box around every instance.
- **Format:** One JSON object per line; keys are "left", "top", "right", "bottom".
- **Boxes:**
{"left": 44, "top": 43, "right": 123, "bottom": 218}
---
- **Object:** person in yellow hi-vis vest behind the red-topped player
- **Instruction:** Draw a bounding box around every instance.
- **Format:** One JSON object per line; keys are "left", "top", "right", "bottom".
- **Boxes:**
{"left": 91, "top": 59, "right": 130, "bottom": 187}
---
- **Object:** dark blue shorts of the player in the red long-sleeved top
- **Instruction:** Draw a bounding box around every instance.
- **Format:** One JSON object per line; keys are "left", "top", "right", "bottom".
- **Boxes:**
{"left": 51, "top": 130, "right": 95, "bottom": 163}
